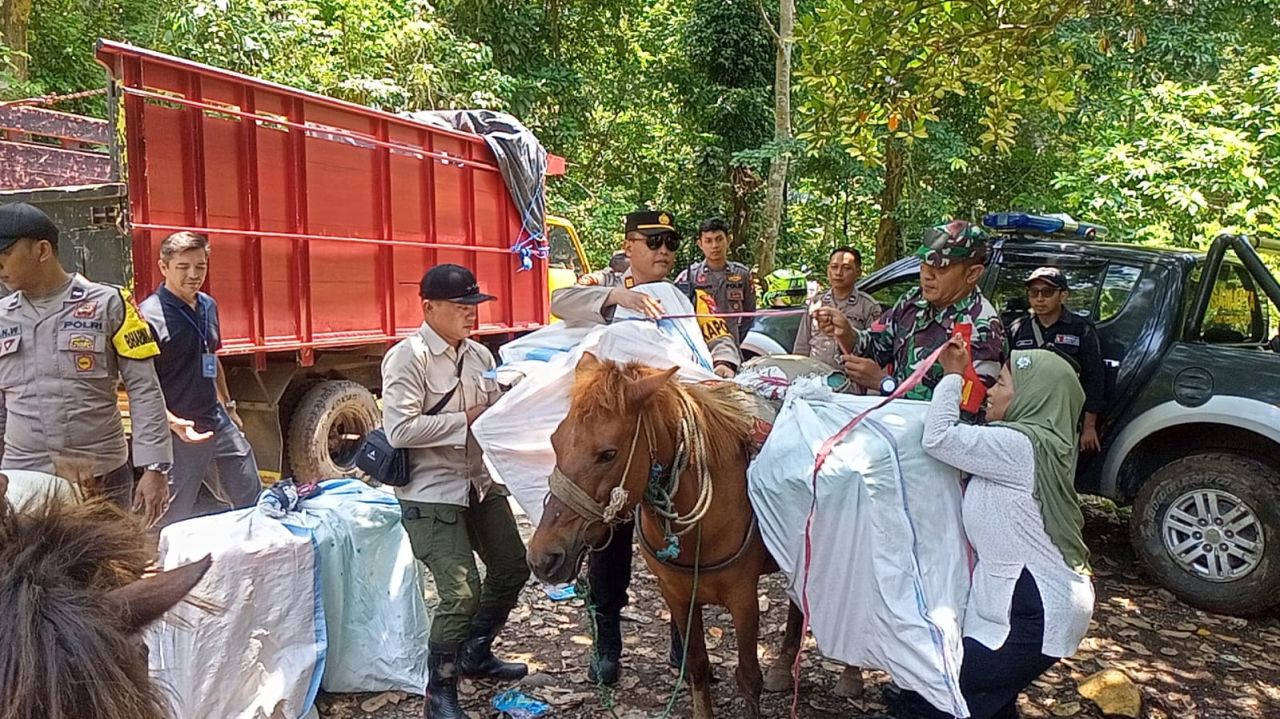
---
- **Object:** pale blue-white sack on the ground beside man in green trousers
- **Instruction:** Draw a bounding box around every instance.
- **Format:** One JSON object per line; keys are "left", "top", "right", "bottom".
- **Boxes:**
{"left": 272, "top": 478, "right": 429, "bottom": 695}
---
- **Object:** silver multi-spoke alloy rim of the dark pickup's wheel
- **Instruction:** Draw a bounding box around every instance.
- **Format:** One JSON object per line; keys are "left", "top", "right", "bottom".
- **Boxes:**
{"left": 1161, "top": 489, "right": 1266, "bottom": 582}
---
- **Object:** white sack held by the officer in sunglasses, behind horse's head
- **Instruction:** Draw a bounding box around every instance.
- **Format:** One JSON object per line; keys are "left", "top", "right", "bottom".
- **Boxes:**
{"left": 471, "top": 283, "right": 716, "bottom": 525}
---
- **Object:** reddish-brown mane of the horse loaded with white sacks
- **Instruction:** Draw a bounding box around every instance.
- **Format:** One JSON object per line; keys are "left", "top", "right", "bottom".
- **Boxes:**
{"left": 570, "top": 361, "right": 751, "bottom": 467}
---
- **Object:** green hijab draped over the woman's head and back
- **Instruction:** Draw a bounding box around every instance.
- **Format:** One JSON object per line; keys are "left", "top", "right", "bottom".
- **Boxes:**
{"left": 993, "top": 349, "right": 1089, "bottom": 573}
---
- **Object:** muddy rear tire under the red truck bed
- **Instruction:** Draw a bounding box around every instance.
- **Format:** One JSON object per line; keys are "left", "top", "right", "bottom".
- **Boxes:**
{"left": 288, "top": 380, "right": 383, "bottom": 481}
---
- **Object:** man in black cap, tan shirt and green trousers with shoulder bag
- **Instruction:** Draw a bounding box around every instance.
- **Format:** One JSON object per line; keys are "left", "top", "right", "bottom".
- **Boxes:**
{"left": 383, "top": 265, "right": 529, "bottom": 719}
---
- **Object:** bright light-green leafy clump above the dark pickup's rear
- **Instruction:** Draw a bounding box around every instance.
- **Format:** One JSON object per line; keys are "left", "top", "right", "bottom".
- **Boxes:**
{"left": 1053, "top": 56, "right": 1280, "bottom": 246}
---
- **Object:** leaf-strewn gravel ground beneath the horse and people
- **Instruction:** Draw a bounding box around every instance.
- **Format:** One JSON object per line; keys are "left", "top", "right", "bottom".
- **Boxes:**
{"left": 319, "top": 500, "right": 1280, "bottom": 719}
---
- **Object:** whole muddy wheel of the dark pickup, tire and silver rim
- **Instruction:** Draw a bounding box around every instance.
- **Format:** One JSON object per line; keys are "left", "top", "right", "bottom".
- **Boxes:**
{"left": 1129, "top": 452, "right": 1280, "bottom": 615}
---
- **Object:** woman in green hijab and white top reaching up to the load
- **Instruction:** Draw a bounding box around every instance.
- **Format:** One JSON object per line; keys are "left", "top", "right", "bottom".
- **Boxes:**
{"left": 893, "top": 338, "right": 1093, "bottom": 719}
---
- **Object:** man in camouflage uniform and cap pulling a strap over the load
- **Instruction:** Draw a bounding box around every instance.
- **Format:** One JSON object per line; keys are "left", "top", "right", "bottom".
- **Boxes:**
{"left": 815, "top": 220, "right": 1007, "bottom": 406}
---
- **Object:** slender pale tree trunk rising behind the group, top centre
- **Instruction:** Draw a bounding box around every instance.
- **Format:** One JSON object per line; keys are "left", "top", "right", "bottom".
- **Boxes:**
{"left": 755, "top": 0, "right": 796, "bottom": 276}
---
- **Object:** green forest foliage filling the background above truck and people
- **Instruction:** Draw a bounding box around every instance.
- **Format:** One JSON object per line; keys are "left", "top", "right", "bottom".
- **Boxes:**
{"left": 15, "top": 0, "right": 1280, "bottom": 276}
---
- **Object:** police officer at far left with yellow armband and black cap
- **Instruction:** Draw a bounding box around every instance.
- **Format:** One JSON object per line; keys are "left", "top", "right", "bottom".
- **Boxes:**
{"left": 0, "top": 202, "right": 173, "bottom": 522}
